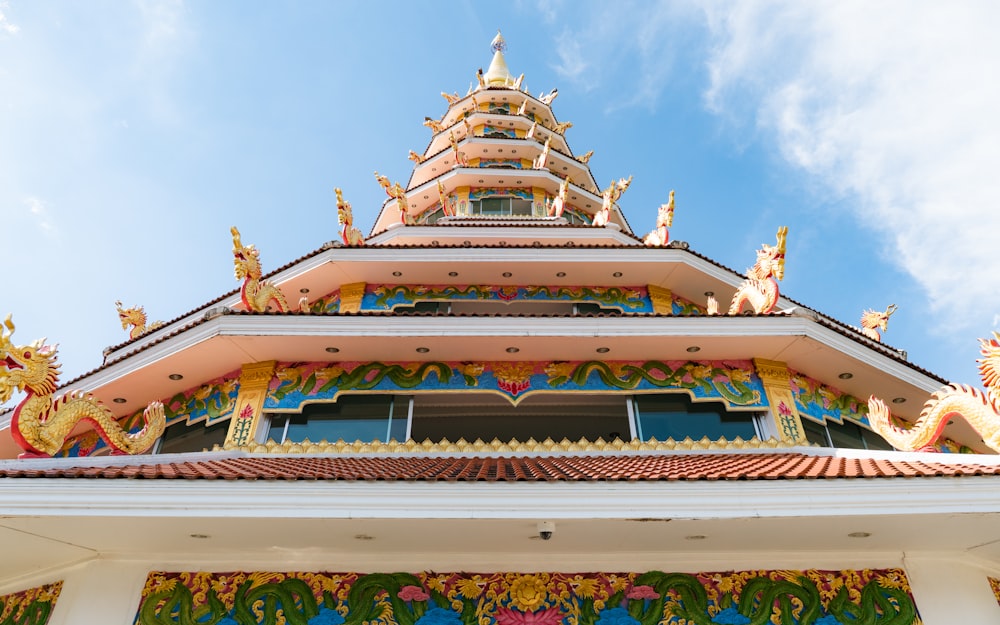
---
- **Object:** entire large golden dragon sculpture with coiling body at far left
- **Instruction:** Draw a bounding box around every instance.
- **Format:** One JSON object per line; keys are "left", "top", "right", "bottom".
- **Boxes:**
{"left": 0, "top": 315, "right": 166, "bottom": 458}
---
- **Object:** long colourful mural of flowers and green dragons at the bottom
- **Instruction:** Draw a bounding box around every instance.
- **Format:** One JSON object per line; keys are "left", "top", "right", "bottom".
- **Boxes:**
{"left": 135, "top": 569, "right": 920, "bottom": 625}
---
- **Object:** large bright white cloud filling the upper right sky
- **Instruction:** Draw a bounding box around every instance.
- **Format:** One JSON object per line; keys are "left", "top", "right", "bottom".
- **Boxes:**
{"left": 706, "top": 0, "right": 1000, "bottom": 336}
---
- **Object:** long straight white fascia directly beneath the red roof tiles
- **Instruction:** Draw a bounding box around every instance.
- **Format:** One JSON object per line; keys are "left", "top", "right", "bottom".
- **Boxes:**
{"left": 0, "top": 476, "right": 1000, "bottom": 519}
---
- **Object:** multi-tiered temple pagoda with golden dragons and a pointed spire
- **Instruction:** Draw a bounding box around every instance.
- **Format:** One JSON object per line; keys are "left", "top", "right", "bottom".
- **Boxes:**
{"left": 0, "top": 35, "right": 1000, "bottom": 625}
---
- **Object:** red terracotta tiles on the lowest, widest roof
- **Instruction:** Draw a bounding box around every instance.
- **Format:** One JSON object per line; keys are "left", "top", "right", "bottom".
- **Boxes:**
{"left": 0, "top": 452, "right": 1000, "bottom": 482}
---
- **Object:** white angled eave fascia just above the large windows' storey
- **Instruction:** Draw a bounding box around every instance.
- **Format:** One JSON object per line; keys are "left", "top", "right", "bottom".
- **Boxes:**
{"left": 86, "top": 314, "right": 941, "bottom": 393}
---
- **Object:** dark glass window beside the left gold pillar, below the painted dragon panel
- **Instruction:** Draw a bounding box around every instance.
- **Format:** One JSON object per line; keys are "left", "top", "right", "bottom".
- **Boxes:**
{"left": 268, "top": 395, "right": 406, "bottom": 443}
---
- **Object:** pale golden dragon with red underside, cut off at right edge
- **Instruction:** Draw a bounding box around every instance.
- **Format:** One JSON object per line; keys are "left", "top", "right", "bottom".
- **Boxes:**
{"left": 868, "top": 332, "right": 1000, "bottom": 452}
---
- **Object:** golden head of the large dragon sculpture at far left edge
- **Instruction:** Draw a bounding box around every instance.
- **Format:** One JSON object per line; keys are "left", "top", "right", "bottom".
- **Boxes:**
{"left": 0, "top": 315, "right": 59, "bottom": 403}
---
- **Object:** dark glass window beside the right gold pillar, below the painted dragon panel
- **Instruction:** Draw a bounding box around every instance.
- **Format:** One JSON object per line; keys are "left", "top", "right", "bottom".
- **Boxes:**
{"left": 635, "top": 394, "right": 757, "bottom": 441}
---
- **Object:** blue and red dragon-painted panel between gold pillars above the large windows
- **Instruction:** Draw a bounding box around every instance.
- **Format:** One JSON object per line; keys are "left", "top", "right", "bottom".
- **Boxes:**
{"left": 264, "top": 360, "right": 767, "bottom": 410}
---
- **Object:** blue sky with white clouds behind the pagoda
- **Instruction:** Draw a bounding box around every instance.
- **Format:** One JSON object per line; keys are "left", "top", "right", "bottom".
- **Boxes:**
{"left": 0, "top": 0, "right": 1000, "bottom": 385}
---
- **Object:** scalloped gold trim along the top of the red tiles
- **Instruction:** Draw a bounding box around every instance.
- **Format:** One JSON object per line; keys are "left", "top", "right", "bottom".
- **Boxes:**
{"left": 219, "top": 436, "right": 789, "bottom": 455}
